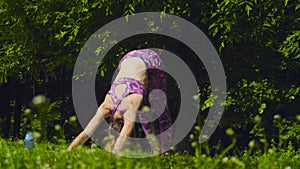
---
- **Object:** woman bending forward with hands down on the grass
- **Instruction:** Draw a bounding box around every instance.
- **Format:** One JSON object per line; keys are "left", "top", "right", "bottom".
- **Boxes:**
{"left": 68, "top": 49, "right": 172, "bottom": 154}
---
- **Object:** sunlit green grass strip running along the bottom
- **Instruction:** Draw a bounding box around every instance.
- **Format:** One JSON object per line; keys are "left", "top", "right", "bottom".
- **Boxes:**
{"left": 0, "top": 139, "right": 300, "bottom": 169}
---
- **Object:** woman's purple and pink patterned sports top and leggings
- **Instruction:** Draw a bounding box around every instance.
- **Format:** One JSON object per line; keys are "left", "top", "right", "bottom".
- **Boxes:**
{"left": 108, "top": 49, "right": 172, "bottom": 152}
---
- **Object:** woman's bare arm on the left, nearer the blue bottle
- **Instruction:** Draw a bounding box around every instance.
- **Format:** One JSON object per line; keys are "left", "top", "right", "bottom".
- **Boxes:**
{"left": 67, "top": 105, "right": 109, "bottom": 151}
